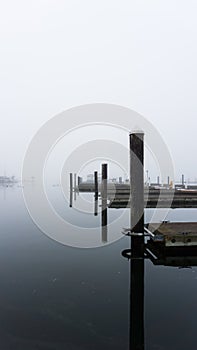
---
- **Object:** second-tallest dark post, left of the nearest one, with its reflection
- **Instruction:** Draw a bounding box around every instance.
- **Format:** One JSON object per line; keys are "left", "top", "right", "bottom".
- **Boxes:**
{"left": 101, "top": 164, "right": 107, "bottom": 243}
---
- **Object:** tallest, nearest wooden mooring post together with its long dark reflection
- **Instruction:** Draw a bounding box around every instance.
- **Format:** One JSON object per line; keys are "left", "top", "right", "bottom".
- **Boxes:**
{"left": 130, "top": 132, "right": 144, "bottom": 350}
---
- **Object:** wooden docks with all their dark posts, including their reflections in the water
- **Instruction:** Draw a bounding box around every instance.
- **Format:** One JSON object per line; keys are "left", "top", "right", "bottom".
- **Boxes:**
{"left": 67, "top": 131, "right": 197, "bottom": 350}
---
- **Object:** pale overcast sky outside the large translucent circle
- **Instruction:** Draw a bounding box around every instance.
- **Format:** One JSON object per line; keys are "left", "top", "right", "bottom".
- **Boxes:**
{"left": 0, "top": 0, "right": 197, "bottom": 183}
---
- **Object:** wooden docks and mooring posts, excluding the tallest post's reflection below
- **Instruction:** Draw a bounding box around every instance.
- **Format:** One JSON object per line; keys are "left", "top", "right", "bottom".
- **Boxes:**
{"left": 70, "top": 131, "right": 197, "bottom": 247}
